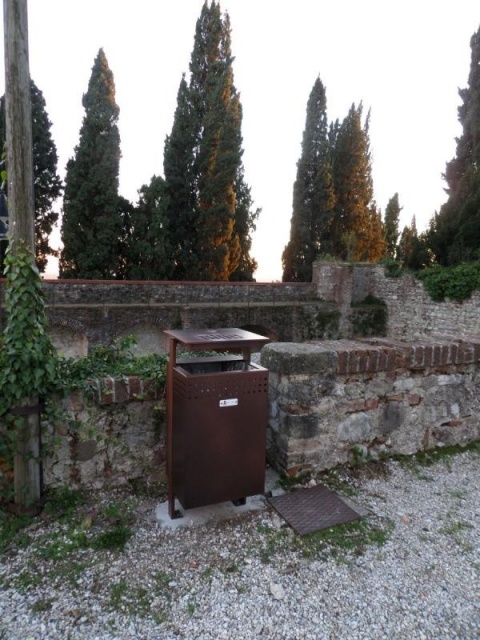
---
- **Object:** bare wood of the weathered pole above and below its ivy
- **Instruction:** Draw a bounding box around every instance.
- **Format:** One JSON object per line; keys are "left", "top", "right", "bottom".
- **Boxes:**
{"left": 3, "top": 0, "right": 41, "bottom": 512}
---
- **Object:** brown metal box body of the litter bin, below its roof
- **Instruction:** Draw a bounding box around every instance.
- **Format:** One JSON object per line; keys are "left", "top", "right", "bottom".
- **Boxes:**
{"left": 172, "top": 358, "right": 268, "bottom": 509}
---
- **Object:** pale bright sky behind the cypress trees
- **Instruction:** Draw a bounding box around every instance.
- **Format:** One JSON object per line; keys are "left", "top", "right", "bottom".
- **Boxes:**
{"left": 0, "top": 0, "right": 480, "bottom": 282}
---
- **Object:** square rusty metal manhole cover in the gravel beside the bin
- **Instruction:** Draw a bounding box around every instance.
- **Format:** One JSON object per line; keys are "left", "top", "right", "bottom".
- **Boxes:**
{"left": 269, "top": 484, "right": 362, "bottom": 536}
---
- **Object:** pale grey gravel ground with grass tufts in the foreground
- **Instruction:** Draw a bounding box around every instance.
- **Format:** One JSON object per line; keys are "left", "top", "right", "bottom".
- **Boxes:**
{"left": 0, "top": 451, "right": 480, "bottom": 640}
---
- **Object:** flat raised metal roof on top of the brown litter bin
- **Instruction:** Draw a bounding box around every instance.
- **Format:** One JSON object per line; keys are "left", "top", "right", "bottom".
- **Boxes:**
{"left": 164, "top": 328, "right": 270, "bottom": 349}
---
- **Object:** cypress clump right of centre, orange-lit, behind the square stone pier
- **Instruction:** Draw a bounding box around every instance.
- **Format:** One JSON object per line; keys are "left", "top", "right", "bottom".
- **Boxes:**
{"left": 282, "top": 90, "right": 386, "bottom": 282}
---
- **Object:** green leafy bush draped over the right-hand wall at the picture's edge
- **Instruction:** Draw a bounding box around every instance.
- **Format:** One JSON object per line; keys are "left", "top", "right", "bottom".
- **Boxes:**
{"left": 417, "top": 261, "right": 480, "bottom": 302}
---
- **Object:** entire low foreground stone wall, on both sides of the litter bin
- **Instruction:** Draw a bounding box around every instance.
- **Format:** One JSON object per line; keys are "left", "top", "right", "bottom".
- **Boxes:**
{"left": 39, "top": 336, "right": 480, "bottom": 488}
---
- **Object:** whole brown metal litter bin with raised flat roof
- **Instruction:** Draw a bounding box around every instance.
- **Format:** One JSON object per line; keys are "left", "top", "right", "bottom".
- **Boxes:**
{"left": 165, "top": 329, "right": 269, "bottom": 518}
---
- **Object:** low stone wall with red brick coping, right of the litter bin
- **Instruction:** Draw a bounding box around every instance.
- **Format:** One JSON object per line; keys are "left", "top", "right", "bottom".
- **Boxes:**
{"left": 261, "top": 336, "right": 480, "bottom": 474}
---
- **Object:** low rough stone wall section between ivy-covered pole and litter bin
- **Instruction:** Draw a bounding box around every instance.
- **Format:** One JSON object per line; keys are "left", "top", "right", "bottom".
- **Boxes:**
{"left": 44, "top": 377, "right": 166, "bottom": 489}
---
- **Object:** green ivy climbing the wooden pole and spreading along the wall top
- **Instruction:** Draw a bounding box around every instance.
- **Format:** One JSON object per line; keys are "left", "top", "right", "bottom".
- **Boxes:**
{"left": 0, "top": 243, "right": 166, "bottom": 508}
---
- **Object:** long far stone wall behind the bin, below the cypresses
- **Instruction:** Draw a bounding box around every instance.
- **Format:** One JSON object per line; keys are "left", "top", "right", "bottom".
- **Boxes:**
{"left": 0, "top": 280, "right": 334, "bottom": 356}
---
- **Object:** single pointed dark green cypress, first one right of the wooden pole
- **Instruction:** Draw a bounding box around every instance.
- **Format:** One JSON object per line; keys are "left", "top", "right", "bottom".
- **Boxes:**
{"left": 59, "top": 49, "right": 124, "bottom": 279}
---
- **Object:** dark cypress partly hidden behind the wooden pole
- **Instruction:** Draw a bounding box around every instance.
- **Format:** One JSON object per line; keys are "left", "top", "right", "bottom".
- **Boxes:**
{"left": 0, "top": 80, "right": 62, "bottom": 273}
